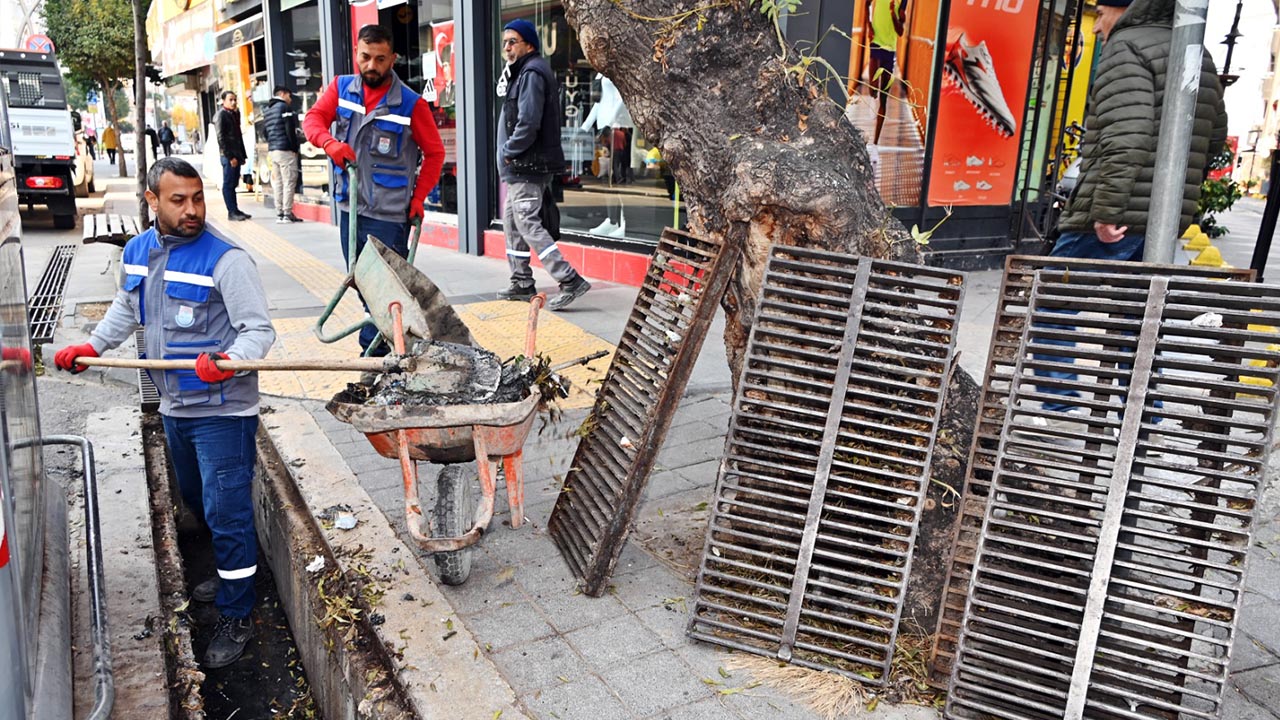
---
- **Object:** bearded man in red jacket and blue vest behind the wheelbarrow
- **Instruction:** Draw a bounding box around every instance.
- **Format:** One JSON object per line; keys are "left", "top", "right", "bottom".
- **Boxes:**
{"left": 302, "top": 26, "right": 444, "bottom": 355}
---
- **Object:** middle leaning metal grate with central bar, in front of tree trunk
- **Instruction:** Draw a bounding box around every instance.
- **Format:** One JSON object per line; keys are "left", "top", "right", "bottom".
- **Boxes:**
{"left": 687, "top": 246, "right": 963, "bottom": 684}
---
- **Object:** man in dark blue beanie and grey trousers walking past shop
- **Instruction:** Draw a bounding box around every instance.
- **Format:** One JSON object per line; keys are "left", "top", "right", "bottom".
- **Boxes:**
{"left": 498, "top": 19, "right": 588, "bottom": 310}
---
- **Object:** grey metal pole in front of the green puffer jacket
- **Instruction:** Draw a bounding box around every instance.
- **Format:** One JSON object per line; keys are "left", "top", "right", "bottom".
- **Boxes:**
{"left": 1142, "top": 0, "right": 1208, "bottom": 264}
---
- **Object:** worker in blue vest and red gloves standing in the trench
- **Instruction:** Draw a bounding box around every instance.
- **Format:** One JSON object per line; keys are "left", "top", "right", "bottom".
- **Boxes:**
{"left": 54, "top": 158, "right": 275, "bottom": 667}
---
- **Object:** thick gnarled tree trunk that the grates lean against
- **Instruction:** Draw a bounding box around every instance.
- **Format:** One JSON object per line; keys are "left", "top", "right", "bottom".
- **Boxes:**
{"left": 564, "top": 0, "right": 919, "bottom": 382}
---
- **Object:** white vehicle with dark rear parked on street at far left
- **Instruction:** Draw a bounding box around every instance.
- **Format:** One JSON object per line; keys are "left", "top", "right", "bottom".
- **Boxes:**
{"left": 0, "top": 50, "right": 87, "bottom": 229}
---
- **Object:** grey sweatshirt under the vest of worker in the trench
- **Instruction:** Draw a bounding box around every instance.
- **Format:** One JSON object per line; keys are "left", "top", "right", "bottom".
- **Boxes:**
{"left": 90, "top": 229, "right": 275, "bottom": 418}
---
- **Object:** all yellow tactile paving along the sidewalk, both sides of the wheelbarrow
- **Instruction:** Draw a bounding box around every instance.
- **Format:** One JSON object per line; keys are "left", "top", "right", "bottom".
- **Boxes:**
{"left": 209, "top": 195, "right": 614, "bottom": 409}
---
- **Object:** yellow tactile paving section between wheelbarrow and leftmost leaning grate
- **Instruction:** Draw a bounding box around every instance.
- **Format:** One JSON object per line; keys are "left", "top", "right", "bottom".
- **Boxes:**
{"left": 454, "top": 300, "right": 614, "bottom": 407}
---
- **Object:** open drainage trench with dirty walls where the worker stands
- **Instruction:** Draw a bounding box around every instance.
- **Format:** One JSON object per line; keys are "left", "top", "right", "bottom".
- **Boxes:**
{"left": 142, "top": 413, "right": 417, "bottom": 720}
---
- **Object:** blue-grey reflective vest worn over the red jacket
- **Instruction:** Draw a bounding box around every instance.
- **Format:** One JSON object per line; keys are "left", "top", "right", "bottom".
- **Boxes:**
{"left": 330, "top": 73, "right": 421, "bottom": 223}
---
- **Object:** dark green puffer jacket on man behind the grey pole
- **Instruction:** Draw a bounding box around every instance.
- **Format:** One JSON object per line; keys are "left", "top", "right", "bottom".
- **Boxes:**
{"left": 1059, "top": 0, "right": 1226, "bottom": 234}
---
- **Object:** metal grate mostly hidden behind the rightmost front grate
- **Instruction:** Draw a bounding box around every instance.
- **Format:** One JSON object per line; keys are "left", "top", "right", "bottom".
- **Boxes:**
{"left": 932, "top": 256, "right": 1253, "bottom": 685}
